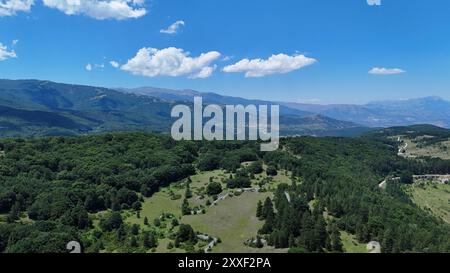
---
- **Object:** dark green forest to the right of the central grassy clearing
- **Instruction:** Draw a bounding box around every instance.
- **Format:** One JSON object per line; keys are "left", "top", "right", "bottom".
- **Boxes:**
{"left": 260, "top": 137, "right": 450, "bottom": 252}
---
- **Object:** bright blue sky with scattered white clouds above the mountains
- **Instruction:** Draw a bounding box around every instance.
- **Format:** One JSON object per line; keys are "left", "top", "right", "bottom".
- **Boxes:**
{"left": 0, "top": 0, "right": 450, "bottom": 104}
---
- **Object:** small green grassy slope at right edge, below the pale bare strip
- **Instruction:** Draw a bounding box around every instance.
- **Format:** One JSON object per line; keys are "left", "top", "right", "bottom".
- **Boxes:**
{"left": 406, "top": 181, "right": 450, "bottom": 223}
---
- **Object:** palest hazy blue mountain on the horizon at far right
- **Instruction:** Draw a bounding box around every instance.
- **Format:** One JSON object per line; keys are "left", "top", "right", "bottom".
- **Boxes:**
{"left": 281, "top": 97, "right": 450, "bottom": 128}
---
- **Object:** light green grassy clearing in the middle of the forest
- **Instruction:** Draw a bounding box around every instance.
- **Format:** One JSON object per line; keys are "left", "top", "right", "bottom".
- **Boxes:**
{"left": 123, "top": 163, "right": 291, "bottom": 252}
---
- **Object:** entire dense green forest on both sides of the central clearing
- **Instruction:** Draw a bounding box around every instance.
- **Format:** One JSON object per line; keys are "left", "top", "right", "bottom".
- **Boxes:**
{"left": 0, "top": 133, "right": 450, "bottom": 252}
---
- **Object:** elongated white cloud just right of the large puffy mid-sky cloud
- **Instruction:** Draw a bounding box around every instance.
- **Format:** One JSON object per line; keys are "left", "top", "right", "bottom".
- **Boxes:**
{"left": 223, "top": 54, "right": 317, "bottom": 78}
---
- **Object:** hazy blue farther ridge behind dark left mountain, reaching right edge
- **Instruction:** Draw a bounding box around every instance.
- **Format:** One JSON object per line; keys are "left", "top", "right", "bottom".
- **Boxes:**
{"left": 120, "top": 87, "right": 450, "bottom": 128}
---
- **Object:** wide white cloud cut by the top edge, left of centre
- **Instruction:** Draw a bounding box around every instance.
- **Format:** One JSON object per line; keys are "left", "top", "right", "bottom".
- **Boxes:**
{"left": 43, "top": 0, "right": 147, "bottom": 20}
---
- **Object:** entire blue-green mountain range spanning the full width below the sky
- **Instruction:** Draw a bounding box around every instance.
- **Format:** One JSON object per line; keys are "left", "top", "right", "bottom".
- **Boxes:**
{"left": 0, "top": 80, "right": 450, "bottom": 137}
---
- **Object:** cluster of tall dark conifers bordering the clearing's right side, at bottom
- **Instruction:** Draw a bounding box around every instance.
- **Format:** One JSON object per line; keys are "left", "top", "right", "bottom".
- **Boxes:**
{"left": 256, "top": 183, "right": 344, "bottom": 253}
